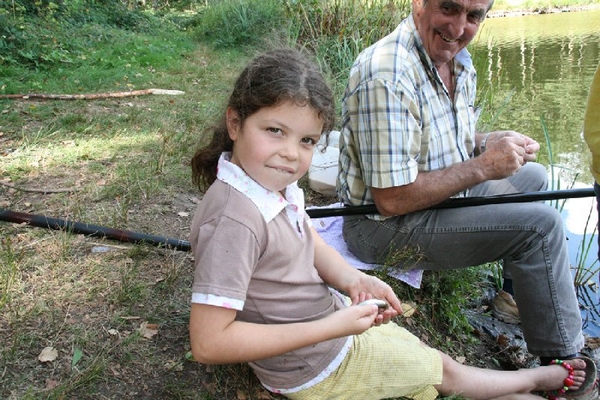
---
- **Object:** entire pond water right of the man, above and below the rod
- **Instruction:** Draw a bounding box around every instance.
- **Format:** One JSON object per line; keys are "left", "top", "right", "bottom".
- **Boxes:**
{"left": 469, "top": 9, "right": 600, "bottom": 337}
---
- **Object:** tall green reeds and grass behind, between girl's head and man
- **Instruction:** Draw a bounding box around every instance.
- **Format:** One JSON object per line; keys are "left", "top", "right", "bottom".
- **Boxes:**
{"left": 191, "top": 0, "right": 410, "bottom": 108}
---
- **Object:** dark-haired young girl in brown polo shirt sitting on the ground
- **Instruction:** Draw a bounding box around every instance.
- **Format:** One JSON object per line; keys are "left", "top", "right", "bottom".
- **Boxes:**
{"left": 190, "top": 50, "right": 586, "bottom": 400}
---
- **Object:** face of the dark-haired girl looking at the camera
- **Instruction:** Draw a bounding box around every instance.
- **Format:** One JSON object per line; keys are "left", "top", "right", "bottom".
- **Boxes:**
{"left": 227, "top": 101, "right": 323, "bottom": 192}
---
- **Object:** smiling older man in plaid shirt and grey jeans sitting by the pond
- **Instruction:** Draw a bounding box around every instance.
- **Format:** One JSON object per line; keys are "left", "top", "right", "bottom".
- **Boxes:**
{"left": 337, "top": 0, "right": 584, "bottom": 364}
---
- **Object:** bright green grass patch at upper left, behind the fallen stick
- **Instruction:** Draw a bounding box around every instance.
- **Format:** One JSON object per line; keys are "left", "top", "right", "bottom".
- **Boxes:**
{"left": 0, "top": 15, "right": 194, "bottom": 97}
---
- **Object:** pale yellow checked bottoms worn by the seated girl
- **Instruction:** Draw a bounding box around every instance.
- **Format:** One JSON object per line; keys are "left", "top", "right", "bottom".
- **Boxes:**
{"left": 286, "top": 322, "right": 442, "bottom": 400}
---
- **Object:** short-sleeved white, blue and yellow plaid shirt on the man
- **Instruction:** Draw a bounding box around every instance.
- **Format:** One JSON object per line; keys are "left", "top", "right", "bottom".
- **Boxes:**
{"left": 337, "top": 14, "right": 477, "bottom": 219}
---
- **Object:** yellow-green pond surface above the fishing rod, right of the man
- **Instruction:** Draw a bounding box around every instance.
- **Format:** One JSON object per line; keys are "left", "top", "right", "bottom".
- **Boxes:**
{"left": 470, "top": 10, "right": 600, "bottom": 183}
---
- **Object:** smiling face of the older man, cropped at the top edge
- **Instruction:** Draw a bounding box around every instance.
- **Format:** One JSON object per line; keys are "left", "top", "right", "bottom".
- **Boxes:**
{"left": 413, "top": 0, "right": 492, "bottom": 67}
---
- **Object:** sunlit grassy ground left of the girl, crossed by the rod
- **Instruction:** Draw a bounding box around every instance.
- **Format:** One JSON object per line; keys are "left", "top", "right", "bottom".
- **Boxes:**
{"left": 0, "top": 7, "right": 256, "bottom": 399}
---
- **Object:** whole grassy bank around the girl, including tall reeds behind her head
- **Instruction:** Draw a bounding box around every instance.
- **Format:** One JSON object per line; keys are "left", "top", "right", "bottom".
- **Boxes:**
{"left": 0, "top": 0, "right": 596, "bottom": 399}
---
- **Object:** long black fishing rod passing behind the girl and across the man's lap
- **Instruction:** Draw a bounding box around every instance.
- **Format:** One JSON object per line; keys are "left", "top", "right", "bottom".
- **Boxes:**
{"left": 0, "top": 188, "right": 595, "bottom": 251}
